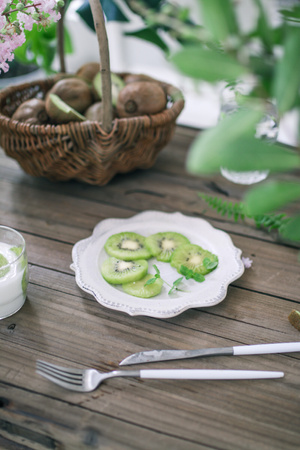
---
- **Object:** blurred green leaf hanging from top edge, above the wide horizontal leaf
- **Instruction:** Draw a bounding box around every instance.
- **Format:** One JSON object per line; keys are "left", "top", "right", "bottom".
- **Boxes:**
{"left": 200, "top": 0, "right": 238, "bottom": 41}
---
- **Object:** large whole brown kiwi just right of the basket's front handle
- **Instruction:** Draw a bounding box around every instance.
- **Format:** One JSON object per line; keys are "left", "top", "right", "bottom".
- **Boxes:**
{"left": 116, "top": 81, "right": 167, "bottom": 117}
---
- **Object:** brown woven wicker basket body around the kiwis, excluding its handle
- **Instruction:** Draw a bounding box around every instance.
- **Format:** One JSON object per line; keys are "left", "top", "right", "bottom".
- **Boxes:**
{"left": 0, "top": 74, "right": 184, "bottom": 185}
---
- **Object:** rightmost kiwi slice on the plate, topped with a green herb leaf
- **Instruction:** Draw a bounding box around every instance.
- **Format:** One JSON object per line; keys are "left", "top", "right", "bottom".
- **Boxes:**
{"left": 171, "top": 244, "right": 218, "bottom": 275}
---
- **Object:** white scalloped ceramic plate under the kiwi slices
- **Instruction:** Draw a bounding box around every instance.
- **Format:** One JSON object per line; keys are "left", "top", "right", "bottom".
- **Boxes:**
{"left": 71, "top": 211, "right": 244, "bottom": 318}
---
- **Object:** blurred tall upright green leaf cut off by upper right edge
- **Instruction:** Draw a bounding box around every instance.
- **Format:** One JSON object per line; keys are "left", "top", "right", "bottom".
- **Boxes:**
{"left": 273, "top": 27, "right": 300, "bottom": 115}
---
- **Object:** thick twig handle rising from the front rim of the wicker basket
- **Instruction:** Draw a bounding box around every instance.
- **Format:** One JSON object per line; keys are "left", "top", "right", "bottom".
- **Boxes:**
{"left": 89, "top": 0, "right": 113, "bottom": 133}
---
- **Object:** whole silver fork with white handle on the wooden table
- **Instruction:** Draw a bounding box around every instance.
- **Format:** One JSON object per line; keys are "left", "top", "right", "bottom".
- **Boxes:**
{"left": 36, "top": 360, "right": 284, "bottom": 392}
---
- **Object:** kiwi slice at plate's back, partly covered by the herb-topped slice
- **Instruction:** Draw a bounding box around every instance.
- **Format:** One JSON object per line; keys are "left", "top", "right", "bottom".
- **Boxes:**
{"left": 145, "top": 231, "right": 190, "bottom": 262}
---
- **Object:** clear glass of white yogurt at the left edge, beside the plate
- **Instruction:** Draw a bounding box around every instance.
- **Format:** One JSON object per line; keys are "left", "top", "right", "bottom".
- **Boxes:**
{"left": 0, "top": 226, "right": 28, "bottom": 319}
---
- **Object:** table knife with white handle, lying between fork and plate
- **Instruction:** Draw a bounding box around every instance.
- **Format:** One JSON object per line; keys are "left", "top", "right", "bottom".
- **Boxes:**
{"left": 119, "top": 342, "right": 300, "bottom": 366}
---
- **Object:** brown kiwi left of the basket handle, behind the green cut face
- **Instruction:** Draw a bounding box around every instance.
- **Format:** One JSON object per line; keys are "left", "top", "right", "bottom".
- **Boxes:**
{"left": 46, "top": 78, "right": 93, "bottom": 113}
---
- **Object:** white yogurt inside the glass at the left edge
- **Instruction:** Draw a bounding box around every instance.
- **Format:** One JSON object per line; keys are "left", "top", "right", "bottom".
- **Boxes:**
{"left": 0, "top": 242, "right": 28, "bottom": 319}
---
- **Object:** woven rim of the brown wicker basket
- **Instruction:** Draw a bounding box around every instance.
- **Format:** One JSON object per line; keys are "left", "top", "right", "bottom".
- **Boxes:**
{"left": 0, "top": 72, "right": 185, "bottom": 136}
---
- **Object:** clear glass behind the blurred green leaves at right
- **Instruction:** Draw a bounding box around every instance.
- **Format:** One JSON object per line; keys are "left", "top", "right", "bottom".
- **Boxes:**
{"left": 219, "top": 83, "right": 278, "bottom": 185}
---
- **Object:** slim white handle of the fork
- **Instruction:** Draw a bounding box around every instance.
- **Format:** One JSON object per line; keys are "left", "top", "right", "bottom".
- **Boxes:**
{"left": 140, "top": 369, "right": 284, "bottom": 380}
